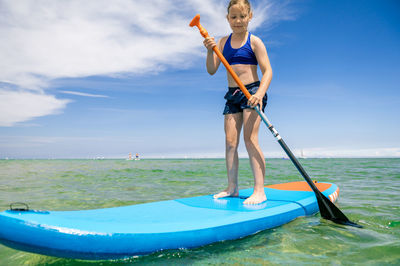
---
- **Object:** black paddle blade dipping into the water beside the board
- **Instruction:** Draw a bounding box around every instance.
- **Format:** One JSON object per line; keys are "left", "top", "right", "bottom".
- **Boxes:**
{"left": 316, "top": 193, "right": 362, "bottom": 228}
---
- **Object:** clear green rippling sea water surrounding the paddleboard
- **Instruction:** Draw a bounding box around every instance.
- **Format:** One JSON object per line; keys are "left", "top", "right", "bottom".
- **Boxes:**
{"left": 0, "top": 159, "right": 400, "bottom": 265}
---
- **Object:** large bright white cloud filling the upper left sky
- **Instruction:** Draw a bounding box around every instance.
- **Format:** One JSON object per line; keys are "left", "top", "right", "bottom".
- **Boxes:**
{"left": 0, "top": 0, "right": 214, "bottom": 88}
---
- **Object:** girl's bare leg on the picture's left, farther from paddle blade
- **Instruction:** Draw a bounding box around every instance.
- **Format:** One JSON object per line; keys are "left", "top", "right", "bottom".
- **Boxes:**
{"left": 214, "top": 113, "right": 243, "bottom": 198}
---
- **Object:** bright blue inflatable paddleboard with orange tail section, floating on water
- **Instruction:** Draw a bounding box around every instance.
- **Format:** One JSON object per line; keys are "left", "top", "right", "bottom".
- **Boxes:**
{"left": 0, "top": 182, "right": 339, "bottom": 259}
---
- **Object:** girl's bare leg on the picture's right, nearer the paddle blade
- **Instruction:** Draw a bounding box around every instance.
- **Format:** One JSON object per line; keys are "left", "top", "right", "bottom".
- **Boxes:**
{"left": 243, "top": 109, "right": 267, "bottom": 204}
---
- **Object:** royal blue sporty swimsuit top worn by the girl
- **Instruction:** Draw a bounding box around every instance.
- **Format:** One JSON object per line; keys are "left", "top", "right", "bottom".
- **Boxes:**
{"left": 222, "top": 32, "right": 258, "bottom": 65}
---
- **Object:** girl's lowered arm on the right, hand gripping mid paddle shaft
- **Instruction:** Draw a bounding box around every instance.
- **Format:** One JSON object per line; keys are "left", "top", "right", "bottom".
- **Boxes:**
{"left": 249, "top": 35, "right": 272, "bottom": 107}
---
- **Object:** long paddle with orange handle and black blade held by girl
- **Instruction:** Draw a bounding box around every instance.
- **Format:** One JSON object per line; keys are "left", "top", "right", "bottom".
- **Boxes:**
{"left": 189, "top": 15, "right": 362, "bottom": 227}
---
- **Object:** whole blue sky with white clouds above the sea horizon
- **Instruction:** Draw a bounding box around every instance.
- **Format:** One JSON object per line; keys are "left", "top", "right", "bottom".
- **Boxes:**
{"left": 0, "top": 0, "right": 400, "bottom": 158}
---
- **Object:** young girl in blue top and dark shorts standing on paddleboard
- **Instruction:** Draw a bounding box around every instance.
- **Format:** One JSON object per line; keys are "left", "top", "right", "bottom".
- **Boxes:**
{"left": 204, "top": 0, "right": 272, "bottom": 204}
